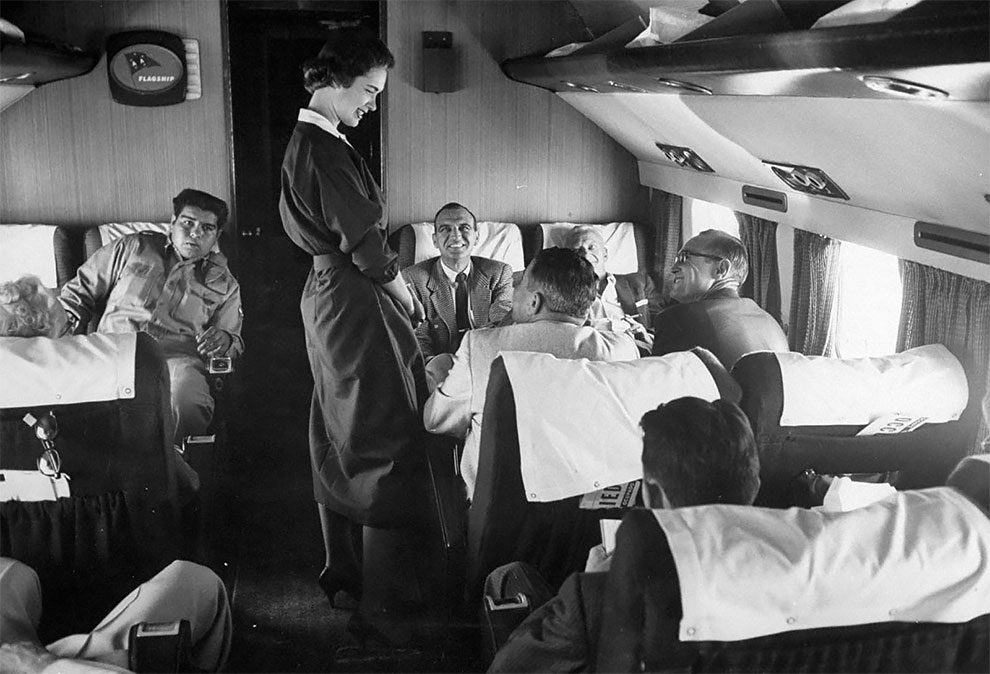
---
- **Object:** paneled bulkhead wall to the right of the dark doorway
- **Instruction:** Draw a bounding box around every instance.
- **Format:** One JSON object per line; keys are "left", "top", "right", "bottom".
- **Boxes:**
{"left": 385, "top": 0, "right": 648, "bottom": 228}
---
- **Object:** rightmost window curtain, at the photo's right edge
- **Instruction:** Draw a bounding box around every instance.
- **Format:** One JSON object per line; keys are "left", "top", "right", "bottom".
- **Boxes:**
{"left": 897, "top": 260, "right": 990, "bottom": 454}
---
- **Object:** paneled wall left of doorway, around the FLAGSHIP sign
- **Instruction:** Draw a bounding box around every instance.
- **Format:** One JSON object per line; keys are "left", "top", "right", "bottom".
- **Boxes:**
{"left": 0, "top": 0, "right": 231, "bottom": 224}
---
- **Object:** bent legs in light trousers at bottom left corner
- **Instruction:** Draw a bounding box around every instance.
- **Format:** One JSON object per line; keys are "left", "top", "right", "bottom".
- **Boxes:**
{"left": 0, "top": 557, "right": 232, "bottom": 674}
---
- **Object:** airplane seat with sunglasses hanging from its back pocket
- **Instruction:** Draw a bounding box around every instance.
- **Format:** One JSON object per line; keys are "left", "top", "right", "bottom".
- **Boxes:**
{"left": 0, "top": 333, "right": 182, "bottom": 636}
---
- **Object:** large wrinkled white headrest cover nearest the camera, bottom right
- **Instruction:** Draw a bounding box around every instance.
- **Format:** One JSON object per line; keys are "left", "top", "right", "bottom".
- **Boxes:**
{"left": 654, "top": 487, "right": 990, "bottom": 641}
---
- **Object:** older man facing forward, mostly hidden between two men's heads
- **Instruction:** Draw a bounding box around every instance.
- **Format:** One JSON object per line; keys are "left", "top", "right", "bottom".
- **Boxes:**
{"left": 564, "top": 225, "right": 660, "bottom": 348}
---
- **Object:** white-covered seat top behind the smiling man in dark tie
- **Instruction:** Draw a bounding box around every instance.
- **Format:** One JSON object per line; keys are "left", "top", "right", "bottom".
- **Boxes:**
{"left": 392, "top": 220, "right": 529, "bottom": 283}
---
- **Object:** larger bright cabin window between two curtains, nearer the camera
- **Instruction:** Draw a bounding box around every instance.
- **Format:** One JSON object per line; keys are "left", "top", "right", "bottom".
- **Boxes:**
{"left": 835, "top": 241, "right": 901, "bottom": 358}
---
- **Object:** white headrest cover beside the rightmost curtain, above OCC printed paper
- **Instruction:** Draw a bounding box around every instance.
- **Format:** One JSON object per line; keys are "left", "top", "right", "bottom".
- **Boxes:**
{"left": 774, "top": 344, "right": 969, "bottom": 426}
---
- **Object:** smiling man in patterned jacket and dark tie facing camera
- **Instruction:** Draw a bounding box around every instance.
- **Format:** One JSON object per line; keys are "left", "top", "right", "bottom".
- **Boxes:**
{"left": 402, "top": 203, "right": 512, "bottom": 364}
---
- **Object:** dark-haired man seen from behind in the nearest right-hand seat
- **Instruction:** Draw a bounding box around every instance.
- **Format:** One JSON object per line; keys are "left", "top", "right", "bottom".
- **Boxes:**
{"left": 485, "top": 398, "right": 760, "bottom": 672}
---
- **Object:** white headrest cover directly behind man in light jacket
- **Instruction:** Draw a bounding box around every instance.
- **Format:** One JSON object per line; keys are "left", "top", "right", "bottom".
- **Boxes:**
{"left": 502, "top": 351, "right": 719, "bottom": 501}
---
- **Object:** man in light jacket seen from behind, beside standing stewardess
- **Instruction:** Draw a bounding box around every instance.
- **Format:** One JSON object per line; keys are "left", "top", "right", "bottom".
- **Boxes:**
{"left": 423, "top": 248, "right": 639, "bottom": 498}
